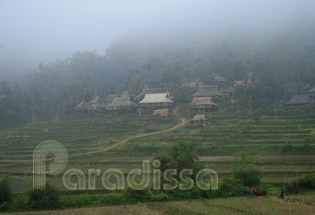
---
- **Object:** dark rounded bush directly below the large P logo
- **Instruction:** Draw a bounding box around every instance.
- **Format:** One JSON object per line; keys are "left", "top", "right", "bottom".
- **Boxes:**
{"left": 29, "top": 182, "right": 60, "bottom": 209}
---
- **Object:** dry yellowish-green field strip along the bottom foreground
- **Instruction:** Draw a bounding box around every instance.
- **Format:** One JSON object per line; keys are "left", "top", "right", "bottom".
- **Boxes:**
{"left": 5, "top": 193, "right": 315, "bottom": 215}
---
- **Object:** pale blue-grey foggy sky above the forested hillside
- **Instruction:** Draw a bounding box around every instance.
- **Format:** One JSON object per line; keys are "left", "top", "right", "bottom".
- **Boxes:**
{"left": 0, "top": 0, "right": 315, "bottom": 80}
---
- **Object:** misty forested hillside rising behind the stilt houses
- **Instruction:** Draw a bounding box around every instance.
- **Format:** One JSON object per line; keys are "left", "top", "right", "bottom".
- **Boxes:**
{"left": 0, "top": 29, "right": 315, "bottom": 128}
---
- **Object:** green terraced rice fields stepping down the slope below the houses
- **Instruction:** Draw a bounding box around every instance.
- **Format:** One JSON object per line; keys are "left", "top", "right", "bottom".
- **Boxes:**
{"left": 0, "top": 107, "right": 315, "bottom": 192}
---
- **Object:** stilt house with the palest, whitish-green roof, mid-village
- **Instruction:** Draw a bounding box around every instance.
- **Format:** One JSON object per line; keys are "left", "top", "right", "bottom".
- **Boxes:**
{"left": 139, "top": 93, "right": 173, "bottom": 110}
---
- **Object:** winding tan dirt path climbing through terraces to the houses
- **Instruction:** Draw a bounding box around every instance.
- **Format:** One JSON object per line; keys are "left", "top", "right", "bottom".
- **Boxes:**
{"left": 69, "top": 106, "right": 188, "bottom": 158}
